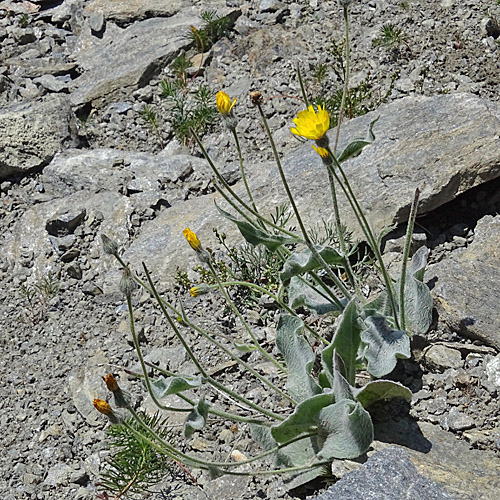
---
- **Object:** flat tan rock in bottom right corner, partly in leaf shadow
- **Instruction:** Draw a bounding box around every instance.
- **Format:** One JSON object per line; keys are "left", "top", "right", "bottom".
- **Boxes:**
{"left": 374, "top": 418, "right": 500, "bottom": 500}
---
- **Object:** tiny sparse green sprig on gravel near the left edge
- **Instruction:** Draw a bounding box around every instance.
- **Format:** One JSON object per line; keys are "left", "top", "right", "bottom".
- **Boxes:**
{"left": 20, "top": 272, "right": 60, "bottom": 327}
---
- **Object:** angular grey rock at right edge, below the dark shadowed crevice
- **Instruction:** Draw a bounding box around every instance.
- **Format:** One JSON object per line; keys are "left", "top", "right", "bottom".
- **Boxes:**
{"left": 426, "top": 215, "right": 500, "bottom": 350}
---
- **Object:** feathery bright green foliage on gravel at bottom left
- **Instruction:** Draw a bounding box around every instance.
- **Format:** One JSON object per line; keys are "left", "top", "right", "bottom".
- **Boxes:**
{"left": 100, "top": 412, "right": 172, "bottom": 498}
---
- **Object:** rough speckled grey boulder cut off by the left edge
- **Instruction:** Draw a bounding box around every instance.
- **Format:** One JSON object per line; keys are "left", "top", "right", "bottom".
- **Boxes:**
{"left": 0, "top": 95, "right": 77, "bottom": 180}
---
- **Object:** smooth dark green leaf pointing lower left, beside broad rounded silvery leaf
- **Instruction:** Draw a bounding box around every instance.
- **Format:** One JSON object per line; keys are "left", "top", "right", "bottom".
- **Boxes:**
{"left": 271, "top": 393, "right": 335, "bottom": 443}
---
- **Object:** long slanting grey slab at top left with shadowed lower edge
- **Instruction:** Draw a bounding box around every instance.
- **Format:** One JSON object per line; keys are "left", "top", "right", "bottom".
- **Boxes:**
{"left": 71, "top": 7, "right": 240, "bottom": 106}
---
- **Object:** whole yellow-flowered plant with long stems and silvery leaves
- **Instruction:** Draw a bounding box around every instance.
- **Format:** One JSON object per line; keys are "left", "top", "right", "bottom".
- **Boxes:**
{"left": 94, "top": 1, "right": 432, "bottom": 490}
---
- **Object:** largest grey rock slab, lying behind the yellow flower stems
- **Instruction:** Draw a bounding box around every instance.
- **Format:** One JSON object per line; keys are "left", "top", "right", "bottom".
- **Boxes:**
{"left": 112, "top": 95, "right": 500, "bottom": 284}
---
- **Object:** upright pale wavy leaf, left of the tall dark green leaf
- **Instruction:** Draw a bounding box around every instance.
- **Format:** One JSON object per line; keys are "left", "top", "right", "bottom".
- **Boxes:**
{"left": 276, "top": 314, "right": 321, "bottom": 402}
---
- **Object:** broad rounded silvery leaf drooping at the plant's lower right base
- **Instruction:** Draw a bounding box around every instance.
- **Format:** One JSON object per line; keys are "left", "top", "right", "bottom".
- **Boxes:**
{"left": 317, "top": 399, "right": 373, "bottom": 460}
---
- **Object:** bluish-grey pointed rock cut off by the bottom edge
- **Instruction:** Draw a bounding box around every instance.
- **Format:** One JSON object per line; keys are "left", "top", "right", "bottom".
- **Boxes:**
{"left": 315, "top": 447, "right": 453, "bottom": 500}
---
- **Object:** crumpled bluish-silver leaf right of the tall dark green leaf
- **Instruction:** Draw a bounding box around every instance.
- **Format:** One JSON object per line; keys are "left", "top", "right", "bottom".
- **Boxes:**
{"left": 361, "top": 315, "right": 411, "bottom": 377}
